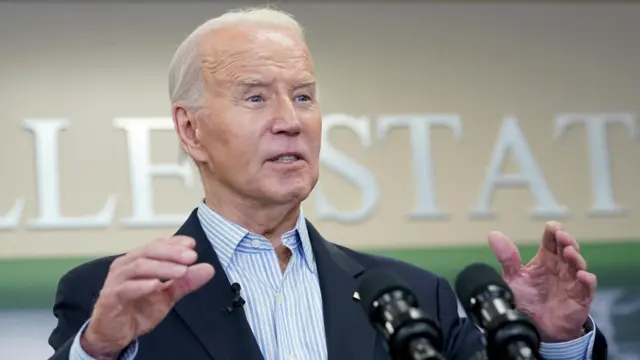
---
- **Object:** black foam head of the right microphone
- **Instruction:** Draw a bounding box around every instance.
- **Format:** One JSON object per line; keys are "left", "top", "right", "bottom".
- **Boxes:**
{"left": 456, "top": 263, "right": 513, "bottom": 311}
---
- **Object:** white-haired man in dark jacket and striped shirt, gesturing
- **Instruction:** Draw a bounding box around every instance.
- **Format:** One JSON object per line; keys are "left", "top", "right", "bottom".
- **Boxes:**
{"left": 49, "top": 9, "right": 606, "bottom": 360}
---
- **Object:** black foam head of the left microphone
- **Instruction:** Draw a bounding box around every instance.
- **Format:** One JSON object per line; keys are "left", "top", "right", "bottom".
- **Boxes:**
{"left": 358, "top": 269, "right": 417, "bottom": 316}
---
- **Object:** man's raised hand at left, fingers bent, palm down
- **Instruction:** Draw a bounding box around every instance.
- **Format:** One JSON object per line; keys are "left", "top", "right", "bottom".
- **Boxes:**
{"left": 80, "top": 236, "right": 214, "bottom": 360}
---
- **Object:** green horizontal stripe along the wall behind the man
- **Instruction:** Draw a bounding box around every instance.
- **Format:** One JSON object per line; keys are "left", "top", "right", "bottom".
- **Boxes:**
{"left": 0, "top": 241, "right": 640, "bottom": 309}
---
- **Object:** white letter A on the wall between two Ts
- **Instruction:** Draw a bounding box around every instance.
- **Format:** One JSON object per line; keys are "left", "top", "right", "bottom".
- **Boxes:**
{"left": 471, "top": 116, "right": 567, "bottom": 218}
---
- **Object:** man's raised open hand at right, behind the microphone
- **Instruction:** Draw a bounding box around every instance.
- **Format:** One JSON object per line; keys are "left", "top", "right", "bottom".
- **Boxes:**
{"left": 489, "top": 222, "right": 597, "bottom": 342}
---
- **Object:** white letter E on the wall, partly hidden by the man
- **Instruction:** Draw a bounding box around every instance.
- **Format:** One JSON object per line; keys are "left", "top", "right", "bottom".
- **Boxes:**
{"left": 113, "top": 118, "right": 194, "bottom": 227}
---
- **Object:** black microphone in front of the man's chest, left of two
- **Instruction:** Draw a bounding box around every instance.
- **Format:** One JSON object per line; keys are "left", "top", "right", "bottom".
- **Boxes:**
{"left": 358, "top": 269, "right": 445, "bottom": 360}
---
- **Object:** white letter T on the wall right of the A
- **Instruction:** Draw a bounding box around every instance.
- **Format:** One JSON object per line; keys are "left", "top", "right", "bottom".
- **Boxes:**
{"left": 555, "top": 114, "right": 636, "bottom": 215}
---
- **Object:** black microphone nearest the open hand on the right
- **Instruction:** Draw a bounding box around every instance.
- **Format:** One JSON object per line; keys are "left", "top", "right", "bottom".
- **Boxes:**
{"left": 456, "top": 264, "right": 542, "bottom": 360}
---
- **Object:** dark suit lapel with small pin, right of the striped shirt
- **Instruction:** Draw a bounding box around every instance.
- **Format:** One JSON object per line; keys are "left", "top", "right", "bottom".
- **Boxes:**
{"left": 307, "top": 221, "right": 377, "bottom": 360}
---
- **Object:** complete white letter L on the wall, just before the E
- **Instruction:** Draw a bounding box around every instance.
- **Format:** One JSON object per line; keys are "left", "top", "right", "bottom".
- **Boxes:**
{"left": 22, "top": 119, "right": 117, "bottom": 230}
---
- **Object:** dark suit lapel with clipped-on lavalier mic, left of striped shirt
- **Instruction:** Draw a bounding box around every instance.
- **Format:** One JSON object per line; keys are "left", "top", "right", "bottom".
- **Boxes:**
{"left": 174, "top": 209, "right": 263, "bottom": 360}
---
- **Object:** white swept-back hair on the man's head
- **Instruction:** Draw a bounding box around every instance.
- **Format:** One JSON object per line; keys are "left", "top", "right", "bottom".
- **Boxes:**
{"left": 169, "top": 7, "right": 305, "bottom": 109}
